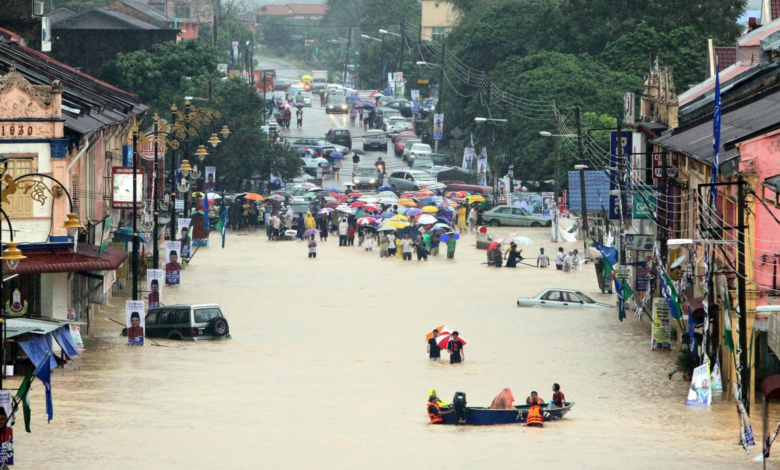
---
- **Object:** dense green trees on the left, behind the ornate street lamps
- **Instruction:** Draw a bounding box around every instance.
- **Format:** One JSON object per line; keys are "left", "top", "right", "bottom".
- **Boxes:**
{"left": 101, "top": 41, "right": 300, "bottom": 189}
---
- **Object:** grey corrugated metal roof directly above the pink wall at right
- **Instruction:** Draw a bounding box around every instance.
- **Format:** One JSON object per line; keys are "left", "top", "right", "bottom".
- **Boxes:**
{"left": 654, "top": 92, "right": 780, "bottom": 164}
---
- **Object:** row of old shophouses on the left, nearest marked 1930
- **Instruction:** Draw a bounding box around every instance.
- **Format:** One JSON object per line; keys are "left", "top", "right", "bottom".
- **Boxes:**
{"left": 0, "top": 28, "right": 146, "bottom": 357}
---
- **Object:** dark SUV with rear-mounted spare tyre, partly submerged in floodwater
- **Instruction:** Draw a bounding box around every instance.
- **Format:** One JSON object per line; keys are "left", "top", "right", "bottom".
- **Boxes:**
{"left": 144, "top": 304, "right": 230, "bottom": 341}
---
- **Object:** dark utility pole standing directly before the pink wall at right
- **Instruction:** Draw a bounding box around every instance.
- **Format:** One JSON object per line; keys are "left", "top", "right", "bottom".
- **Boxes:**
{"left": 737, "top": 173, "right": 751, "bottom": 414}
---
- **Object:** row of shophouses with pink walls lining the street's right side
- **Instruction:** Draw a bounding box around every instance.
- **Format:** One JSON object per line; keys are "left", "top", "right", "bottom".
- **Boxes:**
{"left": 630, "top": 11, "right": 780, "bottom": 400}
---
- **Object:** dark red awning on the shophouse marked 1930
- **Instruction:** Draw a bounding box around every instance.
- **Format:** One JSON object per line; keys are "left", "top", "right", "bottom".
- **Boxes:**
{"left": 5, "top": 245, "right": 127, "bottom": 275}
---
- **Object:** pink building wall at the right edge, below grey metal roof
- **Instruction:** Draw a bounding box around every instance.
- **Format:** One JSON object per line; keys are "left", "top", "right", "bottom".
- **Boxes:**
{"left": 738, "top": 131, "right": 780, "bottom": 296}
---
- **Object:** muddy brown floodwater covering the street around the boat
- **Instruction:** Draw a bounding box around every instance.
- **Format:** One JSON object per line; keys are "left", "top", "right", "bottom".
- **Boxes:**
{"left": 15, "top": 225, "right": 760, "bottom": 470}
